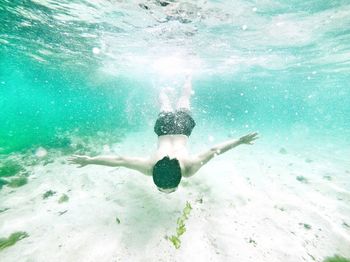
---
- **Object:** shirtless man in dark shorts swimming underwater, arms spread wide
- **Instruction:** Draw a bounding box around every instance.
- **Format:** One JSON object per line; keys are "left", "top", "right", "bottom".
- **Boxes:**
{"left": 69, "top": 77, "right": 258, "bottom": 193}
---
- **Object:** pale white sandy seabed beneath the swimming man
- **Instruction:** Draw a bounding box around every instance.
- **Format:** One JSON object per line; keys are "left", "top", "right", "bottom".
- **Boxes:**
{"left": 0, "top": 129, "right": 350, "bottom": 262}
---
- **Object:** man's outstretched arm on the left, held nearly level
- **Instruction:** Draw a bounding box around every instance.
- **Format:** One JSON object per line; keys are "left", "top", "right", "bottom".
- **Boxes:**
{"left": 68, "top": 155, "right": 150, "bottom": 175}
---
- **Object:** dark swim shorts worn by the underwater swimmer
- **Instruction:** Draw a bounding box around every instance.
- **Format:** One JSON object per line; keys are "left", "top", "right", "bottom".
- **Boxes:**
{"left": 154, "top": 109, "right": 196, "bottom": 136}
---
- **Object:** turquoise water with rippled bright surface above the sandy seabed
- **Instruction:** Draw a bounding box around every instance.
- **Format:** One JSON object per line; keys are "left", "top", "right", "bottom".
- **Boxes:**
{"left": 0, "top": 0, "right": 350, "bottom": 151}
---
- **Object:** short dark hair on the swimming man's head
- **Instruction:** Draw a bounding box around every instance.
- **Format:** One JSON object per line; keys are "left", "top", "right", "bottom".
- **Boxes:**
{"left": 153, "top": 156, "right": 181, "bottom": 189}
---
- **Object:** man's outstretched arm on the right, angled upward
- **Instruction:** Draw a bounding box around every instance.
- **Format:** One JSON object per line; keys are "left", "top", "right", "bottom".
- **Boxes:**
{"left": 188, "top": 132, "right": 258, "bottom": 176}
